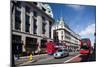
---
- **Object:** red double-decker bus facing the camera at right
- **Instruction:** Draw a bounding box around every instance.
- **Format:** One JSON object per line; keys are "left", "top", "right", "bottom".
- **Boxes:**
{"left": 80, "top": 38, "right": 92, "bottom": 54}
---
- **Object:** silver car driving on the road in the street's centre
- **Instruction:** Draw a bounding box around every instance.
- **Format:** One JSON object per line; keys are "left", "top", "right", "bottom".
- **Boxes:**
{"left": 54, "top": 49, "right": 69, "bottom": 58}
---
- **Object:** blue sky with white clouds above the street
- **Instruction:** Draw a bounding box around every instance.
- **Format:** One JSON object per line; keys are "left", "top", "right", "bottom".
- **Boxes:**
{"left": 50, "top": 3, "right": 96, "bottom": 45}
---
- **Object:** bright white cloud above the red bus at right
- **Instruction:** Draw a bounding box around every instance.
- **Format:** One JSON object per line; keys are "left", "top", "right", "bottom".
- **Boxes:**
{"left": 79, "top": 24, "right": 95, "bottom": 35}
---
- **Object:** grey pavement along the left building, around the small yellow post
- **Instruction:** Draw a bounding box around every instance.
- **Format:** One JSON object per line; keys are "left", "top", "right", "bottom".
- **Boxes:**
{"left": 15, "top": 54, "right": 49, "bottom": 65}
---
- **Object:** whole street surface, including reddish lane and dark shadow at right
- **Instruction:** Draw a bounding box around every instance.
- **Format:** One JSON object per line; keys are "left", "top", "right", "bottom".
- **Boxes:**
{"left": 16, "top": 53, "right": 95, "bottom": 66}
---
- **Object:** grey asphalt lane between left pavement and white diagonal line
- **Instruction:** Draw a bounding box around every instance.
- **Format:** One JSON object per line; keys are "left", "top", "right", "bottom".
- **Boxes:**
{"left": 21, "top": 53, "right": 79, "bottom": 65}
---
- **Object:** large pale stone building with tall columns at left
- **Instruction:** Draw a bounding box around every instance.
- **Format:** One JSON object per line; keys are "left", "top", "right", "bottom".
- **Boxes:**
{"left": 11, "top": 1, "right": 54, "bottom": 53}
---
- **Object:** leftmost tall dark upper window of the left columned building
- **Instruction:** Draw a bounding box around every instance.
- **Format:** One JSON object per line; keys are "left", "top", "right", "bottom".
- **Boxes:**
{"left": 15, "top": 9, "right": 21, "bottom": 30}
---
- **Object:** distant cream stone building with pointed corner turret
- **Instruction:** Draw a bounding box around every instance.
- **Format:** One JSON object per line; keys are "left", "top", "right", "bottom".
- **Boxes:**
{"left": 52, "top": 17, "right": 80, "bottom": 50}
